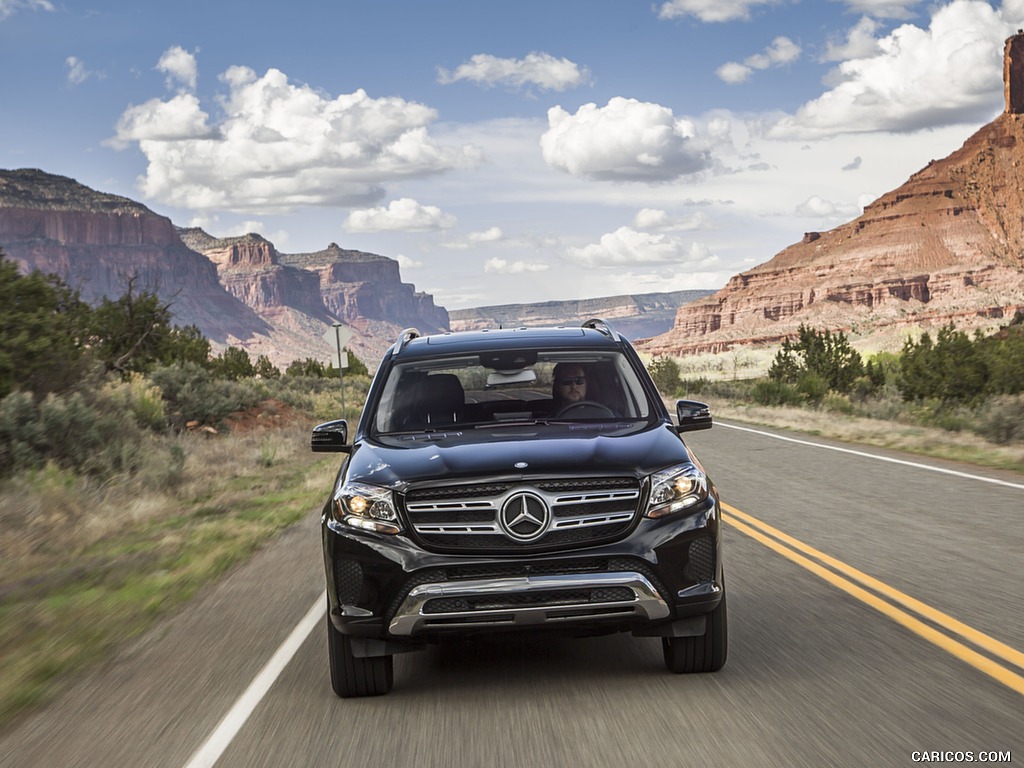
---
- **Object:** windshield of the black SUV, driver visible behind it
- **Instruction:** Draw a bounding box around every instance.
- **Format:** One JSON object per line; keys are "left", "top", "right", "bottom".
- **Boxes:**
{"left": 373, "top": 349, "right": 651, "bottom": 433}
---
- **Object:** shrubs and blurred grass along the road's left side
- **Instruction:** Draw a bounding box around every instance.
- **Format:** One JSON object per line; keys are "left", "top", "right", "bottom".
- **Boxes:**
{"left": 0, "top": 252, "right": 370, "bottom": 728}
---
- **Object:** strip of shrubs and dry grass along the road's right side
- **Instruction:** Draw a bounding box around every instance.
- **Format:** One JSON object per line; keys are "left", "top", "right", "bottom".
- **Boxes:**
{"left": 648, "top": 314, "right": 1024, "bottom": 472}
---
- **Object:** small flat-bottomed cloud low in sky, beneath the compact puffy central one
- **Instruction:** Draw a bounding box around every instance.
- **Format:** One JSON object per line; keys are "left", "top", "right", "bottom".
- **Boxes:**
{"left": 566, "top": 226, "right": 718, "bottom": 269}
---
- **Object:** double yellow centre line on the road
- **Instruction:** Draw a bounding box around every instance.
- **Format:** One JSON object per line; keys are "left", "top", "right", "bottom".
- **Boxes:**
{"left": 722, "top": 504, "right": 1024, "bottom": 695}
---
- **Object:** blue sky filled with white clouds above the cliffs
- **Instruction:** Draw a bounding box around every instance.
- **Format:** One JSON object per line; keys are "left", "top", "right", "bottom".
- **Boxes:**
{"left": 0, "top": 0, "right": 1024, "bottom": 309}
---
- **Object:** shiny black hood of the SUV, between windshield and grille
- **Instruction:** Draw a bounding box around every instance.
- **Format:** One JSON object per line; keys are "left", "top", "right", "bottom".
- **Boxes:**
{"left": 346, "top": 423, "right": 689, "bottom": 490}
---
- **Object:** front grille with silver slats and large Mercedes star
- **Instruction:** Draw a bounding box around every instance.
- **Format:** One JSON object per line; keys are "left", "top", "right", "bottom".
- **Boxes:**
{"left": 402, "top": 477, "right": 641, "bottom": 552}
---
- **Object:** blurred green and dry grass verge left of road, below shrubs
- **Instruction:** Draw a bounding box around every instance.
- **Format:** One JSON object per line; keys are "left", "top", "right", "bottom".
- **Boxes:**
{"left": 0, "top": 428, "right": 336, "bottom": 727}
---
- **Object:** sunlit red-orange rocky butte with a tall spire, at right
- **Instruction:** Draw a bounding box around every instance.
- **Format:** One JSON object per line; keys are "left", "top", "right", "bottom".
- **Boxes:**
{"left": 638, "top": 32, "right": 1024, "bottom": 355}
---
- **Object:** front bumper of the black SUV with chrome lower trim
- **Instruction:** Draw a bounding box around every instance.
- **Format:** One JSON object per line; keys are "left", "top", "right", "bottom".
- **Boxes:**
{"left": 323, "top": 496, "right": 722, "bottom": 642}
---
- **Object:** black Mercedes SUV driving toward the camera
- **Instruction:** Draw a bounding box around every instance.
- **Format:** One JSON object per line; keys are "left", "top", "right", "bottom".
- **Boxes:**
{"left": 311, "top": 319, "right": 727, "bottom": 696}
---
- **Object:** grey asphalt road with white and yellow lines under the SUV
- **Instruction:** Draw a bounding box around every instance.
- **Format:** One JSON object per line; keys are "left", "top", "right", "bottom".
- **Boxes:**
{"left": 0, "top": 425, "right": 1024, "bottom": 768}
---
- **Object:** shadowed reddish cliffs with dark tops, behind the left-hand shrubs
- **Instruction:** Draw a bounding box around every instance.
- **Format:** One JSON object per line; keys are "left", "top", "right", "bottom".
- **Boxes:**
{"left": 0, "top": 169, "right": 447, "bottom": 367}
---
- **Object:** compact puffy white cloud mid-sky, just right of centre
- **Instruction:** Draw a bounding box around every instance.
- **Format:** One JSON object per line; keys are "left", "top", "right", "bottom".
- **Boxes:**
{"left": 541, "top": 96, "right": 711, "bottom": 181}
